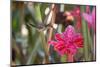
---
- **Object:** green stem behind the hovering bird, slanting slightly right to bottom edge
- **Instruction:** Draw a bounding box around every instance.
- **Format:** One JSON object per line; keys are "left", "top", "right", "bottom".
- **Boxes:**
{"left": 34, "top": 3, "right": 49, "bottom": 63}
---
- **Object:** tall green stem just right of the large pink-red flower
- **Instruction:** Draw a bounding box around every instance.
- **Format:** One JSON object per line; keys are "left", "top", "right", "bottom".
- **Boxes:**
{"left": 81, "top": 6, "right": 90, "bottom": 61}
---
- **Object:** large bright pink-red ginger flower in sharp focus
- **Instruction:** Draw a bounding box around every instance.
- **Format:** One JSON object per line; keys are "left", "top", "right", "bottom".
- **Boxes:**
{"left": 49, "top": 25, "right": 83, "bottom": 55}
